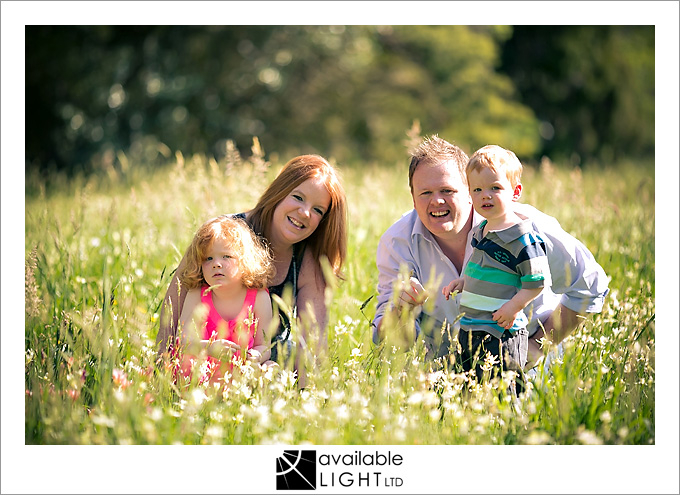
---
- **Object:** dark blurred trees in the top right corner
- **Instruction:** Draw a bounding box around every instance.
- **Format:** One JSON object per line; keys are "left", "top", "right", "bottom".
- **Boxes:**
{"left": 501, "top": 26, "right": 654, "bottom": 165}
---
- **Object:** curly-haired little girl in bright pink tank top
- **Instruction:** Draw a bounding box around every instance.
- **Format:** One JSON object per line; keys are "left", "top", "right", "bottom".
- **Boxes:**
{"left": 179, "top": 216, "right": 273, "bottom": 383}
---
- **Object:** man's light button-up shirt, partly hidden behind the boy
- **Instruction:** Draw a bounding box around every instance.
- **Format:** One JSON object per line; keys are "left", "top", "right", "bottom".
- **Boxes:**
{"left": 373, "top": 203, "right": 609, "bottom": 354}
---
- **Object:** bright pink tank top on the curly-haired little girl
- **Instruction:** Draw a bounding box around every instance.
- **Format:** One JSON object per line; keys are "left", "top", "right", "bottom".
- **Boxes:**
{"left": 201, "top": 287, "right": 257, "bottom": 349}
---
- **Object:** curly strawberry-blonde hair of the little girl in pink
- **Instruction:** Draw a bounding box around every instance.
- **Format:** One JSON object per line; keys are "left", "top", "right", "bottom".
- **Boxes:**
{"left": 179, "top": 215, "right": 274, "bottom": 289}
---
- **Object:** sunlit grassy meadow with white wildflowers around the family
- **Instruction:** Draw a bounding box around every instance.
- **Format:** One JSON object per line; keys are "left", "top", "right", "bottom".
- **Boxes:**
{"left": 24, "top": 144, "right": 656, "bottom": 445}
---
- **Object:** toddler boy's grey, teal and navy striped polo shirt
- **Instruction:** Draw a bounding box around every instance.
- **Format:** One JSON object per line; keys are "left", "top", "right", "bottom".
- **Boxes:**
{"left": 460, "top": 220, "right": 551, "bottom": 338}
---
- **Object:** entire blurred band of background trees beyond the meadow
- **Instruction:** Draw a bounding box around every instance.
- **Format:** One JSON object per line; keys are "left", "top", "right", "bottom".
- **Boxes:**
{"left": 31, "top": 26, "right": 654, "bottom": 177}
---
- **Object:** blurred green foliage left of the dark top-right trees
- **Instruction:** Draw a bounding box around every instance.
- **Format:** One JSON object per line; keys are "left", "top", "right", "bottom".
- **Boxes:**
{"left": 26, "top": 26, "right": 539, "bottom": 175}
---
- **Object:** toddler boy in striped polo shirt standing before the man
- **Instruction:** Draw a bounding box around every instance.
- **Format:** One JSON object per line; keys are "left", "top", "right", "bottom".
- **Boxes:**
{"left": 442, "top": 145, "right": 550, "bottom": 386}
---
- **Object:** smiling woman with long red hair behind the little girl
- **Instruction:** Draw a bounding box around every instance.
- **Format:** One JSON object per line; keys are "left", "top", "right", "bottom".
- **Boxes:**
{"left": 156, "top": 155, "right": 347, "bottom": 368}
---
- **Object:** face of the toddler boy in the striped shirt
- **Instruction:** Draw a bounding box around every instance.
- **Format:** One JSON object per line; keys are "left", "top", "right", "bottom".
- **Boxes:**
{"left": 468, "top": 168, "right": 522, "bottom": 224}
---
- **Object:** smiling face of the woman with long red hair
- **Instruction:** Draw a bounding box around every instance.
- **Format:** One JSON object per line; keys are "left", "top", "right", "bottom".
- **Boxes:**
{"left": 269, "top": 177, "right": 331, "bottom": 245}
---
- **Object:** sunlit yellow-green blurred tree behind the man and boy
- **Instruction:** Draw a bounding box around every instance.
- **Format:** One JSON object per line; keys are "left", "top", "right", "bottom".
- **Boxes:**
{"left": 375, "top": 26, "right": 540, "bottom": 161}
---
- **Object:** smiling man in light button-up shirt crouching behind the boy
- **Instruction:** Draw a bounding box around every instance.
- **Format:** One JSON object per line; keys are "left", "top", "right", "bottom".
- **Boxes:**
{"left": 373, "top": 136, "right": 609, "bottom": 368}
